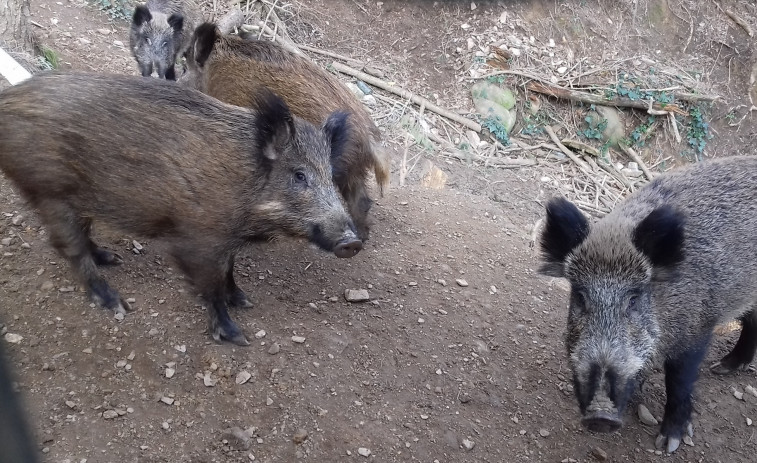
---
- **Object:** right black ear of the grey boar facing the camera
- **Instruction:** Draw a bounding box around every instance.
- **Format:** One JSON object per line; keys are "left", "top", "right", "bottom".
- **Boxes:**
{"left": 633, "top": 205, "right": 684, "bottom": 267}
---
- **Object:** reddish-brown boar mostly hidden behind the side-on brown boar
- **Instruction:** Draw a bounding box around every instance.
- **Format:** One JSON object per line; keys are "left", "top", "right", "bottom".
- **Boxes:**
{"left": 179, "top": 23, "right": 389, "bottom": 240}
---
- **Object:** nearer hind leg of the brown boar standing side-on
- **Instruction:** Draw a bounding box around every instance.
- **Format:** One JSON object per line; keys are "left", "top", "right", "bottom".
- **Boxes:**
{"left": 38, "top": 201, "right": 129, "bottom": 313}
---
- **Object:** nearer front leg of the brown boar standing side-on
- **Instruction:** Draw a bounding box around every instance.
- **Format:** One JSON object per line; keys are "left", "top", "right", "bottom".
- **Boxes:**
{"left": 171, "top": 250, "right": 250, "bottom": 346}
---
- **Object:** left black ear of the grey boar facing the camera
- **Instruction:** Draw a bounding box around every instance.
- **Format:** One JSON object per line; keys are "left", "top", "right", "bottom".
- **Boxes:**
{"left": 539, "top": 198, "right": 589, "bottom": 277}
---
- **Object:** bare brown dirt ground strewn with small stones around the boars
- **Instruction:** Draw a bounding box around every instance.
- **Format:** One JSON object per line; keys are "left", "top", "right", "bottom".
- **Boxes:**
{"left": 0, "top": 0, "right": 757, "bottom": 463}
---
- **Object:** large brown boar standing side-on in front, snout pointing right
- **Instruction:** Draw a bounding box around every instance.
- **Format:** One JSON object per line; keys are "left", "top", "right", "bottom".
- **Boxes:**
{"left": 0, "top": 73, "right": 362, "bottom": 345}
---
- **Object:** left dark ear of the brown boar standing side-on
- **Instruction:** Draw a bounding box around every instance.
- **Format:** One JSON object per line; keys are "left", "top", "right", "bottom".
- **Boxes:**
{"left": 254, "top": 88, "right": 295, "bottom": 168}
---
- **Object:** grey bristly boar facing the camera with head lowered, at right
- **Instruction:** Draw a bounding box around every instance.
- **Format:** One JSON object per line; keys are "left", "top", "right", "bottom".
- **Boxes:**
{"left": 540, "top": 156, "right": 757, "bottom": 452}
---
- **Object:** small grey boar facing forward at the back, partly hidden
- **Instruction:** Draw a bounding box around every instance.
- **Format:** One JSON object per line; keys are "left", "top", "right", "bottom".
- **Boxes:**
{"left": 129, "top": 0, "right": 202, "bottom": 80}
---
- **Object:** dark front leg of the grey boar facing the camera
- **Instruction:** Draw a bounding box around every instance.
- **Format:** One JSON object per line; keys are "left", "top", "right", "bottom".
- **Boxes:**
{"left": 655, "top": 337, "right": 710, "bottom": 453}
